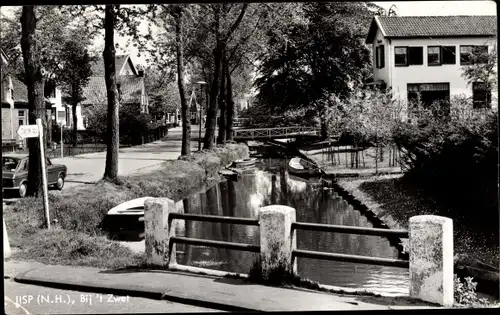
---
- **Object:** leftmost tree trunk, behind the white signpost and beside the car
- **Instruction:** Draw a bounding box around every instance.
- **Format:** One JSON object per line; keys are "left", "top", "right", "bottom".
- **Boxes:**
{"left": 21, "top": 5, "right": 47, "bottom": 198}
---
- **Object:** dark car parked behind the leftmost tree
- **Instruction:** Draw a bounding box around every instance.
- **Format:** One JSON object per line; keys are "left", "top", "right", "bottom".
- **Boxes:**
{"left": 2, "top": 154, "right": 67, "bottom": 198}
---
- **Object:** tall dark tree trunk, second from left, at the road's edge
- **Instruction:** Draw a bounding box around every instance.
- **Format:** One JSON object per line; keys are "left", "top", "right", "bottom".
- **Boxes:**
{"left": 103, "top": 5, "right": 120, "bottom": 181}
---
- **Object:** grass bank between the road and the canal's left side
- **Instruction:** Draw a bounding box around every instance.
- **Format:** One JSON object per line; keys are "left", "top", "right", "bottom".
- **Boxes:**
{"left": 4, "top": 144, "right": 248, "bottom": 268}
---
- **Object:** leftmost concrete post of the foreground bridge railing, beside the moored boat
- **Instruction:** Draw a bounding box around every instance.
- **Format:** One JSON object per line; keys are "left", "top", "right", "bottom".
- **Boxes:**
{"left": 144, "top": 198, "right": 177, "bottom": 267}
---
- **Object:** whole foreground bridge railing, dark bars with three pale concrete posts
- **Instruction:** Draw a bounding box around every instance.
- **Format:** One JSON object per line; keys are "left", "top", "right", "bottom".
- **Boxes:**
{"left": 144, "top": 198, "right": 453, "bottom": 305}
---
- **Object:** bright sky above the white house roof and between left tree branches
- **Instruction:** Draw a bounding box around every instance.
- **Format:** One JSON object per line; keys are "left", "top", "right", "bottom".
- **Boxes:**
{"left": 1, "top": 0, "right": 497, "bottom": 64}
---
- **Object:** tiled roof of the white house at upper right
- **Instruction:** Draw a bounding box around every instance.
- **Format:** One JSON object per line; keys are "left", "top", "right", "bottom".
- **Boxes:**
{"left": 366, "top": 15, "right": 497, "bottom": 43}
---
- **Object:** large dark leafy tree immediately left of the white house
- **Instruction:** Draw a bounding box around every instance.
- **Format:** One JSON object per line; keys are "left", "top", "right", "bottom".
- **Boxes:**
{"left": 256, "top": 2, "right": 374, "bottom": 117}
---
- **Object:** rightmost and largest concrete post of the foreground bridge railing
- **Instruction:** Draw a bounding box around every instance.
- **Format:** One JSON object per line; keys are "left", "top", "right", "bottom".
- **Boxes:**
{"left": 409, "top": 215, "right": 453, "bottom": 306}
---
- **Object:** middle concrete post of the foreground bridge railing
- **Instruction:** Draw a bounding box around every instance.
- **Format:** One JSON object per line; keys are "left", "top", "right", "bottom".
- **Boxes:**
{"left": 259, "top": 205, "right": 297, "bottom": 280}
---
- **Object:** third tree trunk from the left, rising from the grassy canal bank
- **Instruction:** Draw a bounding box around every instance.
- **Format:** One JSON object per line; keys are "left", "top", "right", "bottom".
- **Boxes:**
{"left": 172, "top": 6, "right": 188, "bottom": 155}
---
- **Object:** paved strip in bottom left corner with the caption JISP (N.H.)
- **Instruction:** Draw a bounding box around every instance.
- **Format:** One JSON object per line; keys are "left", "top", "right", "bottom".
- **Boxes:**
{"left": 4, "top": 279, "right": 220, "bottom": 315}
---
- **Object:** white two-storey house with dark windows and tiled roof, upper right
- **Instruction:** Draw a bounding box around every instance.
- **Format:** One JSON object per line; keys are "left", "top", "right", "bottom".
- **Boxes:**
{"left": 366, "top": 16, "right": 497, "bottom": 110}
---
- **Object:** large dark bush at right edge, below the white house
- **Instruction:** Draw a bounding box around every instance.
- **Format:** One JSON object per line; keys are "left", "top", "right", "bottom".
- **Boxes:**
{"left": 393, "top": 101, "right": 498, "bottom": 224}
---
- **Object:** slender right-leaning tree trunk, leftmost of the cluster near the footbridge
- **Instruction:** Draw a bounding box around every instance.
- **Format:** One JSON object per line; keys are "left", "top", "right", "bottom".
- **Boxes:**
{"left": 203, "top": 4, "right": 224, "bottom": 150}
